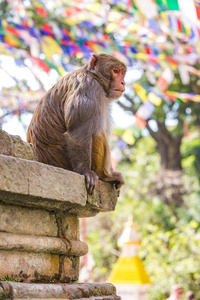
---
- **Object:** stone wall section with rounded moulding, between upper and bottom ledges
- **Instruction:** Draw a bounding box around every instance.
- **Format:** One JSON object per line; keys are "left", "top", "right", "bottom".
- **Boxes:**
{"left": 0, "top": 202, "right": 84, "bottom": 282}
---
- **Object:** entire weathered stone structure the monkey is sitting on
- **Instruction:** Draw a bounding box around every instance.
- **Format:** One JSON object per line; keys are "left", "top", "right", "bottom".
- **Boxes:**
{"left": 0, "top": 130, "right": 117, "bottom": 292}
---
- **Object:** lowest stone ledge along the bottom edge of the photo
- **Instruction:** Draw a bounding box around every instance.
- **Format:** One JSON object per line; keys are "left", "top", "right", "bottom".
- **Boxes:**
{"left": 0, "top": 281, "right": 121, "bottom": 300}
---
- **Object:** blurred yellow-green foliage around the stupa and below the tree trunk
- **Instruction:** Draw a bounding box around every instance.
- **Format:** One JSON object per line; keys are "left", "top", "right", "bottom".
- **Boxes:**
{"left": 88, "top": 131, "right": 200, "bottom": 300}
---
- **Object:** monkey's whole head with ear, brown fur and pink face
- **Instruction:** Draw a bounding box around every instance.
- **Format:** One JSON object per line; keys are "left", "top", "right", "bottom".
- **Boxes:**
{"left": 89, "top": 53, "right": 126, "bottom": 100}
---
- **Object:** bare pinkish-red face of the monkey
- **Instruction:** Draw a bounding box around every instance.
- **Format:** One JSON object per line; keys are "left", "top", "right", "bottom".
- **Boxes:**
{"left": 108, "top": 65, "right": 126, "bottom": 100}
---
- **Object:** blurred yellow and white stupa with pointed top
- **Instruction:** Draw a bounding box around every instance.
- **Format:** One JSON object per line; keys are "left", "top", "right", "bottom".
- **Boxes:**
{"left": 108, "top": 217, "right": 151, "bottom": 300}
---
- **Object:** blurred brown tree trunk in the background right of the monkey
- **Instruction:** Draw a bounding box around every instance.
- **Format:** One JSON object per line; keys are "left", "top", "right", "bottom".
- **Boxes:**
{"left": 146, "top": 123, "right": 186, "bottom": 207}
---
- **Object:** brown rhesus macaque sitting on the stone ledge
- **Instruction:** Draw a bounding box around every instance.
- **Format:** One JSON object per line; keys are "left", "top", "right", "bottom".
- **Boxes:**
{"left": 27, "top": 53, "right": 126, "bottom": 194}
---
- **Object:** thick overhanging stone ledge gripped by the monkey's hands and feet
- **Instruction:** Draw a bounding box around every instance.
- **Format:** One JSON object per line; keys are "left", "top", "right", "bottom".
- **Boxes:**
{"left": 0, "top": 154, "right": 117, "bottom": 217}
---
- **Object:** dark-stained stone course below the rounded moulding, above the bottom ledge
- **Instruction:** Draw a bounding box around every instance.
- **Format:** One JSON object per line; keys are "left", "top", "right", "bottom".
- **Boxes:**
{"left": 0, "top": 250, "right": 79, "bottom": 282}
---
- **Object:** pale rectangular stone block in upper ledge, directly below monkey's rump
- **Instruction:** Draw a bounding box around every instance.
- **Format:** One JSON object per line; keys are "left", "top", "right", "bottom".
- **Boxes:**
{"left": 28, "top": 162, "right": 87, "bottom": 206}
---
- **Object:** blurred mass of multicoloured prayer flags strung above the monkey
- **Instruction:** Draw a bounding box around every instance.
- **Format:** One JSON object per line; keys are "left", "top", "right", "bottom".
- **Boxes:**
{"left": 0, "top": 0, "right": 200, "bottom": 116}
